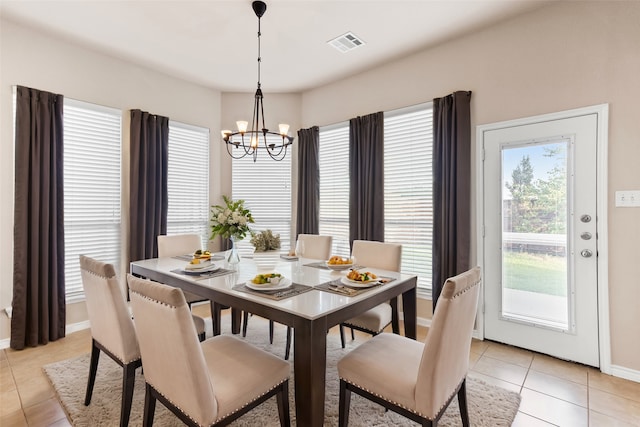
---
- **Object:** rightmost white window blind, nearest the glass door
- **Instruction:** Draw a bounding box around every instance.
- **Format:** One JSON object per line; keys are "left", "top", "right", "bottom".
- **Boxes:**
{"left": 384, "top": 103, "right": 433, "bottom": 292}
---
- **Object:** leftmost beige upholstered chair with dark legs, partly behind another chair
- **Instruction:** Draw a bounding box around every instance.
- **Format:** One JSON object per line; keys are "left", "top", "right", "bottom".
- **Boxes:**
{"left": 80, "top": 255, "right": 205, "bottom": 426}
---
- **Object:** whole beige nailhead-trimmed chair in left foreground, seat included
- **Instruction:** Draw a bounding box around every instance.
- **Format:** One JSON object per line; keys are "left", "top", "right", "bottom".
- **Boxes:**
{"left": 127, "top": 275, "right": 290, "bottom": 426}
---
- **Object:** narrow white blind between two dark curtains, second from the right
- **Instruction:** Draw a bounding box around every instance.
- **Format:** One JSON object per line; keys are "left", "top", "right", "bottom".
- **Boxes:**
{"left": 319, "top": 122, "right": 350, "bottom": 256}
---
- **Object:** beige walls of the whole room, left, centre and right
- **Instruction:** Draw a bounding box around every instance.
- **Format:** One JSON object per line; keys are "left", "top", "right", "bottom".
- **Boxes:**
{"left": 0, "top": 2, "right": 640, "bottom": 372}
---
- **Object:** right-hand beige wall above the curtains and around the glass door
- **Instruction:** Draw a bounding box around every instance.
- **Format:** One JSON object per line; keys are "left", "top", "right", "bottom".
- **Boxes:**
{"left": 302, "top": 2, "right": 640, "bottom": 375}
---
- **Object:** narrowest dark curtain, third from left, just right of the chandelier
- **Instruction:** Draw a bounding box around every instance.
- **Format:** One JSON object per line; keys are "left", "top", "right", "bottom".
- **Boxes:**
{"left": 296, "top": 126, "right": 320, "bottom": 236}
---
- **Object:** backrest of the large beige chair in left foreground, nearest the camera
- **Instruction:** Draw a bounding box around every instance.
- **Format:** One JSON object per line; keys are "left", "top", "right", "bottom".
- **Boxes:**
{"left": 127, "top": 274, "right": 218, "bottom": 425}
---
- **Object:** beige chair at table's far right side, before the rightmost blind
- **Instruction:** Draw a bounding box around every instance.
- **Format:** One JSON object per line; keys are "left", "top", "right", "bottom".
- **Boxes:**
{"left": 340, "top": 240, "right": 402, "bottom": 348}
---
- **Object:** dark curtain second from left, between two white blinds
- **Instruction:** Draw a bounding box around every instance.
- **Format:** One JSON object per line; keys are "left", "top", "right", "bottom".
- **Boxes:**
{"left": 129, "top": 110, "right": 169, "bottom": 261}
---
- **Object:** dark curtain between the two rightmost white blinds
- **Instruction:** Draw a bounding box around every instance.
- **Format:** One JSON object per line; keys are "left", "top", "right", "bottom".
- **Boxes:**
{"left": 349, "top": 112, "right": 384, "bottom": 246}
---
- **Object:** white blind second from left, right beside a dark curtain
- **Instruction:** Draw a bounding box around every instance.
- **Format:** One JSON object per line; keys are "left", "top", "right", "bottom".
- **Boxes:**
{"left": 167, "top": 121, "right": 210, "bottom": 248}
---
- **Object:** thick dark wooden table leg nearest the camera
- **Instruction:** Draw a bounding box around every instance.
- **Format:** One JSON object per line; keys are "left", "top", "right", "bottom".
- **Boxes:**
{"left": 293, "top": 318, "right": 327, "bottom": 427}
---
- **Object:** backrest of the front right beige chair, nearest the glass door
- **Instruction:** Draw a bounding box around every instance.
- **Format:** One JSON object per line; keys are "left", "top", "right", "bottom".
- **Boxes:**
{"left": 416, "top": 267, "right": 480, "bottom": 418}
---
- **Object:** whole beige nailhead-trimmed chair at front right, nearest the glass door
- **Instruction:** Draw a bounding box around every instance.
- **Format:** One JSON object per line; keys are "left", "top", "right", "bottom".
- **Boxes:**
{"left": 338, "top": 267, "right": 480, "bottom": 427}
